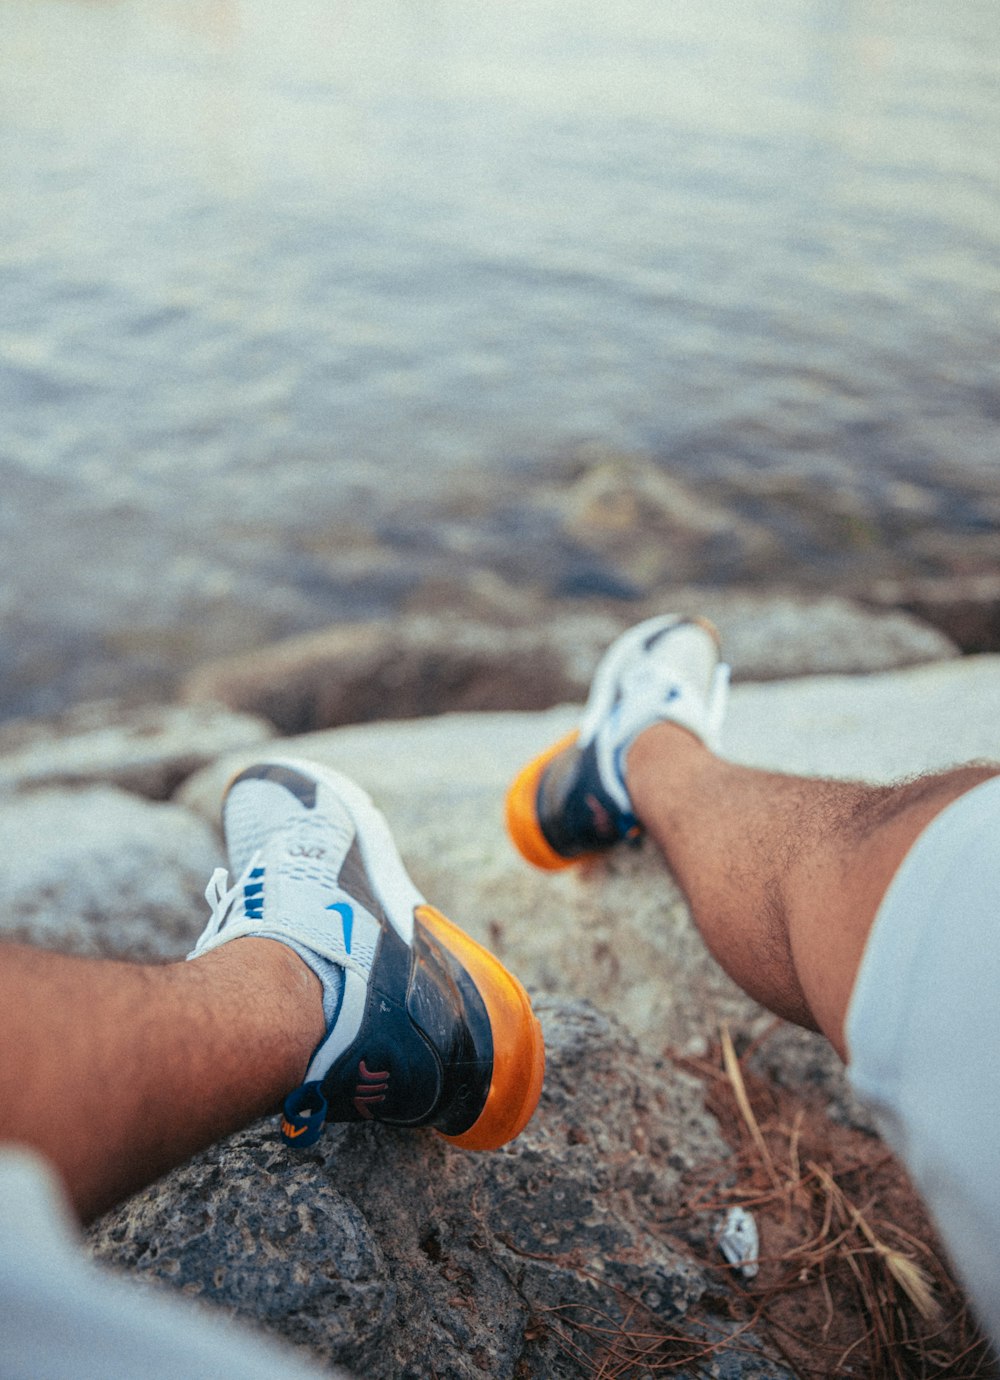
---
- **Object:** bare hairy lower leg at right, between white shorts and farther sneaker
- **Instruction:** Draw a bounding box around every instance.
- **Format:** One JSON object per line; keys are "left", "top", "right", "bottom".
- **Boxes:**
{"left": 628, "top": 723, "right": 1000, "bottom": 1057}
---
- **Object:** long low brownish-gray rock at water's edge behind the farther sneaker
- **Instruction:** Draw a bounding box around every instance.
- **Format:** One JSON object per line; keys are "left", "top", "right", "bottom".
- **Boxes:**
{"left": 181, "top": 591, "right": 956, "bottom": 733}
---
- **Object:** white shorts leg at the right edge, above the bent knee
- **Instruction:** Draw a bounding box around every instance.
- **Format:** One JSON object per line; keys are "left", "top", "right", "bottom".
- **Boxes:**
{"left": 846, "top": 777, "right": 1000, "bottom": 1341}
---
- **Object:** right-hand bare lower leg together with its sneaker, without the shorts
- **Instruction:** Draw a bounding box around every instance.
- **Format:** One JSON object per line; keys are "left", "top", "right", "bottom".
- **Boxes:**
{"left": 508, "top": 614, "right": 1000, "bottom": 1056}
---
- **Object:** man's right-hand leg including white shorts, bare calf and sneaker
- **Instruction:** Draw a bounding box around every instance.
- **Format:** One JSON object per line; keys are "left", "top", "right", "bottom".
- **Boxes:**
{"left": 508, "top": 615, "right": 1000, "bottom": 1341}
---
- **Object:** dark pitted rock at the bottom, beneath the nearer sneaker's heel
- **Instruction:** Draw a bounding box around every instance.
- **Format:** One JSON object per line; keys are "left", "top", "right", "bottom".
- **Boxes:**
{"left": 90, "top": 1001, "right": 788, "bottom": 1380}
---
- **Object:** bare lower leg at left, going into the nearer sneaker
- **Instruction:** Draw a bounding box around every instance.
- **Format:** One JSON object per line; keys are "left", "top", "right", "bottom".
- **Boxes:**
{"left": 0, "top": 938, "right": 324, "bottom": 1220}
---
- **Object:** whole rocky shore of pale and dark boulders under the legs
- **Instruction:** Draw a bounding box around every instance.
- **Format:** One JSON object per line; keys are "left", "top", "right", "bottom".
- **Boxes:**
{"left": 0, "top": 600, "right": 1000, "bottom": 1380}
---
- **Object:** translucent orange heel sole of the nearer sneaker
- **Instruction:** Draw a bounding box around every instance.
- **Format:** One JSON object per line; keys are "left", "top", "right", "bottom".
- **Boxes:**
{"left": 417, "top": 905, "right": 545, "bottom": 1150}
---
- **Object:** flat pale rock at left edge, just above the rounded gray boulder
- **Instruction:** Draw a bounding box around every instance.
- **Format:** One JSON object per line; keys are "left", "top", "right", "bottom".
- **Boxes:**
{"left": 0, "top": 701, "right": 273, "bottom": 800}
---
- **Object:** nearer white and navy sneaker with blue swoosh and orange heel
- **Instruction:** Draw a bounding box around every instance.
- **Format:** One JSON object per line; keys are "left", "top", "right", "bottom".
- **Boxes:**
{"left": 189, "top": 760, "right": 545, "bottom": 1150}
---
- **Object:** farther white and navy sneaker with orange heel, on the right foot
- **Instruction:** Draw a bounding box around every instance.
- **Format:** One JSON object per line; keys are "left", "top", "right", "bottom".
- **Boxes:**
{"left": 506, "top": 614, "right": 730, "bottom": 872}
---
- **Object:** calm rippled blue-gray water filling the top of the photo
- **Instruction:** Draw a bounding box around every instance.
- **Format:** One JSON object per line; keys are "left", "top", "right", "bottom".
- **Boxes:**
{"left": 0, "top": 0, "right": 1000, "bottom": 718}
